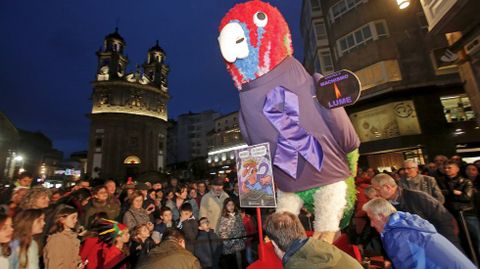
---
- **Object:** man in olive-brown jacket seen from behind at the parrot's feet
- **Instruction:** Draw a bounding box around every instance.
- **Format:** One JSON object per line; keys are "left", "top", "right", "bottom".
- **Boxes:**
{"left": 265, "top": 211, "right": 363, "bottom": 269}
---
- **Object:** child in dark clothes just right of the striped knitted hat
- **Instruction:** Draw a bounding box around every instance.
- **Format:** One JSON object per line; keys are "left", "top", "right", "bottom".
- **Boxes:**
{"left": 130, "top": 224, "right": 156, "bottom": 268}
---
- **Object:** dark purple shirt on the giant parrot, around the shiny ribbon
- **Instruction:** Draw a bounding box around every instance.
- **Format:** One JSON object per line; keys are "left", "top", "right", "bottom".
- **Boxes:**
{"left": 239, "top": 57, "right": 360, "bottom": 192}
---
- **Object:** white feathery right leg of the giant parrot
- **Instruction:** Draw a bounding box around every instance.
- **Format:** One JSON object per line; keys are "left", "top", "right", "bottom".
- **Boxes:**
{"left": 313, "top": 181, "right": 347, "bottom": 232}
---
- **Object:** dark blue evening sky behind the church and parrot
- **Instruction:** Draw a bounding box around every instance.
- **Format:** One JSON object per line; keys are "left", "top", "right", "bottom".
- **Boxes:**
{"left": 0, "top": 0, "right": 303, "bottom": 157}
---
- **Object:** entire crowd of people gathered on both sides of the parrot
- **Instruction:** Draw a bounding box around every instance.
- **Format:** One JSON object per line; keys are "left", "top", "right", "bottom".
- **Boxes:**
{"left": 0, "top": 156, "right": 480, "bottom": 269}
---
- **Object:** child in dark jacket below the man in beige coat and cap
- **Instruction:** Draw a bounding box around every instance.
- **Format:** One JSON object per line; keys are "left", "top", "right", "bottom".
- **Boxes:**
{"left": 195, "top": 217, "right": 222, "bottom": 269}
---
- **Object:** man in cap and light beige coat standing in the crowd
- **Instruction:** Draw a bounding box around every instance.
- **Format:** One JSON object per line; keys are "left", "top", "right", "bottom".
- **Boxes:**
{"left": 200, "top": 178, "right": 229, "bottom": 232}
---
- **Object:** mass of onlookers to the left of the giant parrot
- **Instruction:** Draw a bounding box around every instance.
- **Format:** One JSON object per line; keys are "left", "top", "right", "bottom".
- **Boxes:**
{"left": 0, "top": 172, "right": 256, "bottom": 269}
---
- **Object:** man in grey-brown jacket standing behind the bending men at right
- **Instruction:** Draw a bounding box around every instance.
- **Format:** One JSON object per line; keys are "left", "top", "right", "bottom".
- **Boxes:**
{"left": 398, "top": 159, "right": 445, "bottom": 202}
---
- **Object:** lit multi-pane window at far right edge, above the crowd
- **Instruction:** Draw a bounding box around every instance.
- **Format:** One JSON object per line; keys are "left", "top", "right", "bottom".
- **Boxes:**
{"left": 440, "top": 94, "right": 475, "bottom": 122}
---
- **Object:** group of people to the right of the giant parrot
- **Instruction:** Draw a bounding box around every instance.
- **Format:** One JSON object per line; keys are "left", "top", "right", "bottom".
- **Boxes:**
{"left": 351, "top": 155, "right": 480, "bottom": 268}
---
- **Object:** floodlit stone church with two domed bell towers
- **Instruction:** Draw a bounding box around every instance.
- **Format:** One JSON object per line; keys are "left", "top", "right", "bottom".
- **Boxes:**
{"left": 87, "top": 28, "right": 169, "bottom": 181}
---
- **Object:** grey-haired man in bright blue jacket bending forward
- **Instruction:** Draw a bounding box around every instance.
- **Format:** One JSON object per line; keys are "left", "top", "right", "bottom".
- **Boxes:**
{"left": 362, "top": 198, "right": 476, "bottom": 269}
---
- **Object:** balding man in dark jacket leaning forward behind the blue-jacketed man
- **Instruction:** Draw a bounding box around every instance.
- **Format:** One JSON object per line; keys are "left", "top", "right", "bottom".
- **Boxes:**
{"left": 372, "top": 173, "right": 462, "bottom": 250}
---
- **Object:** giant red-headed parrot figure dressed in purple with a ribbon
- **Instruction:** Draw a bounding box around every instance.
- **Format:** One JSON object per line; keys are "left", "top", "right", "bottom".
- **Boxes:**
{"left": 218, "top": 0, "right": 360, "bottom": 243}
